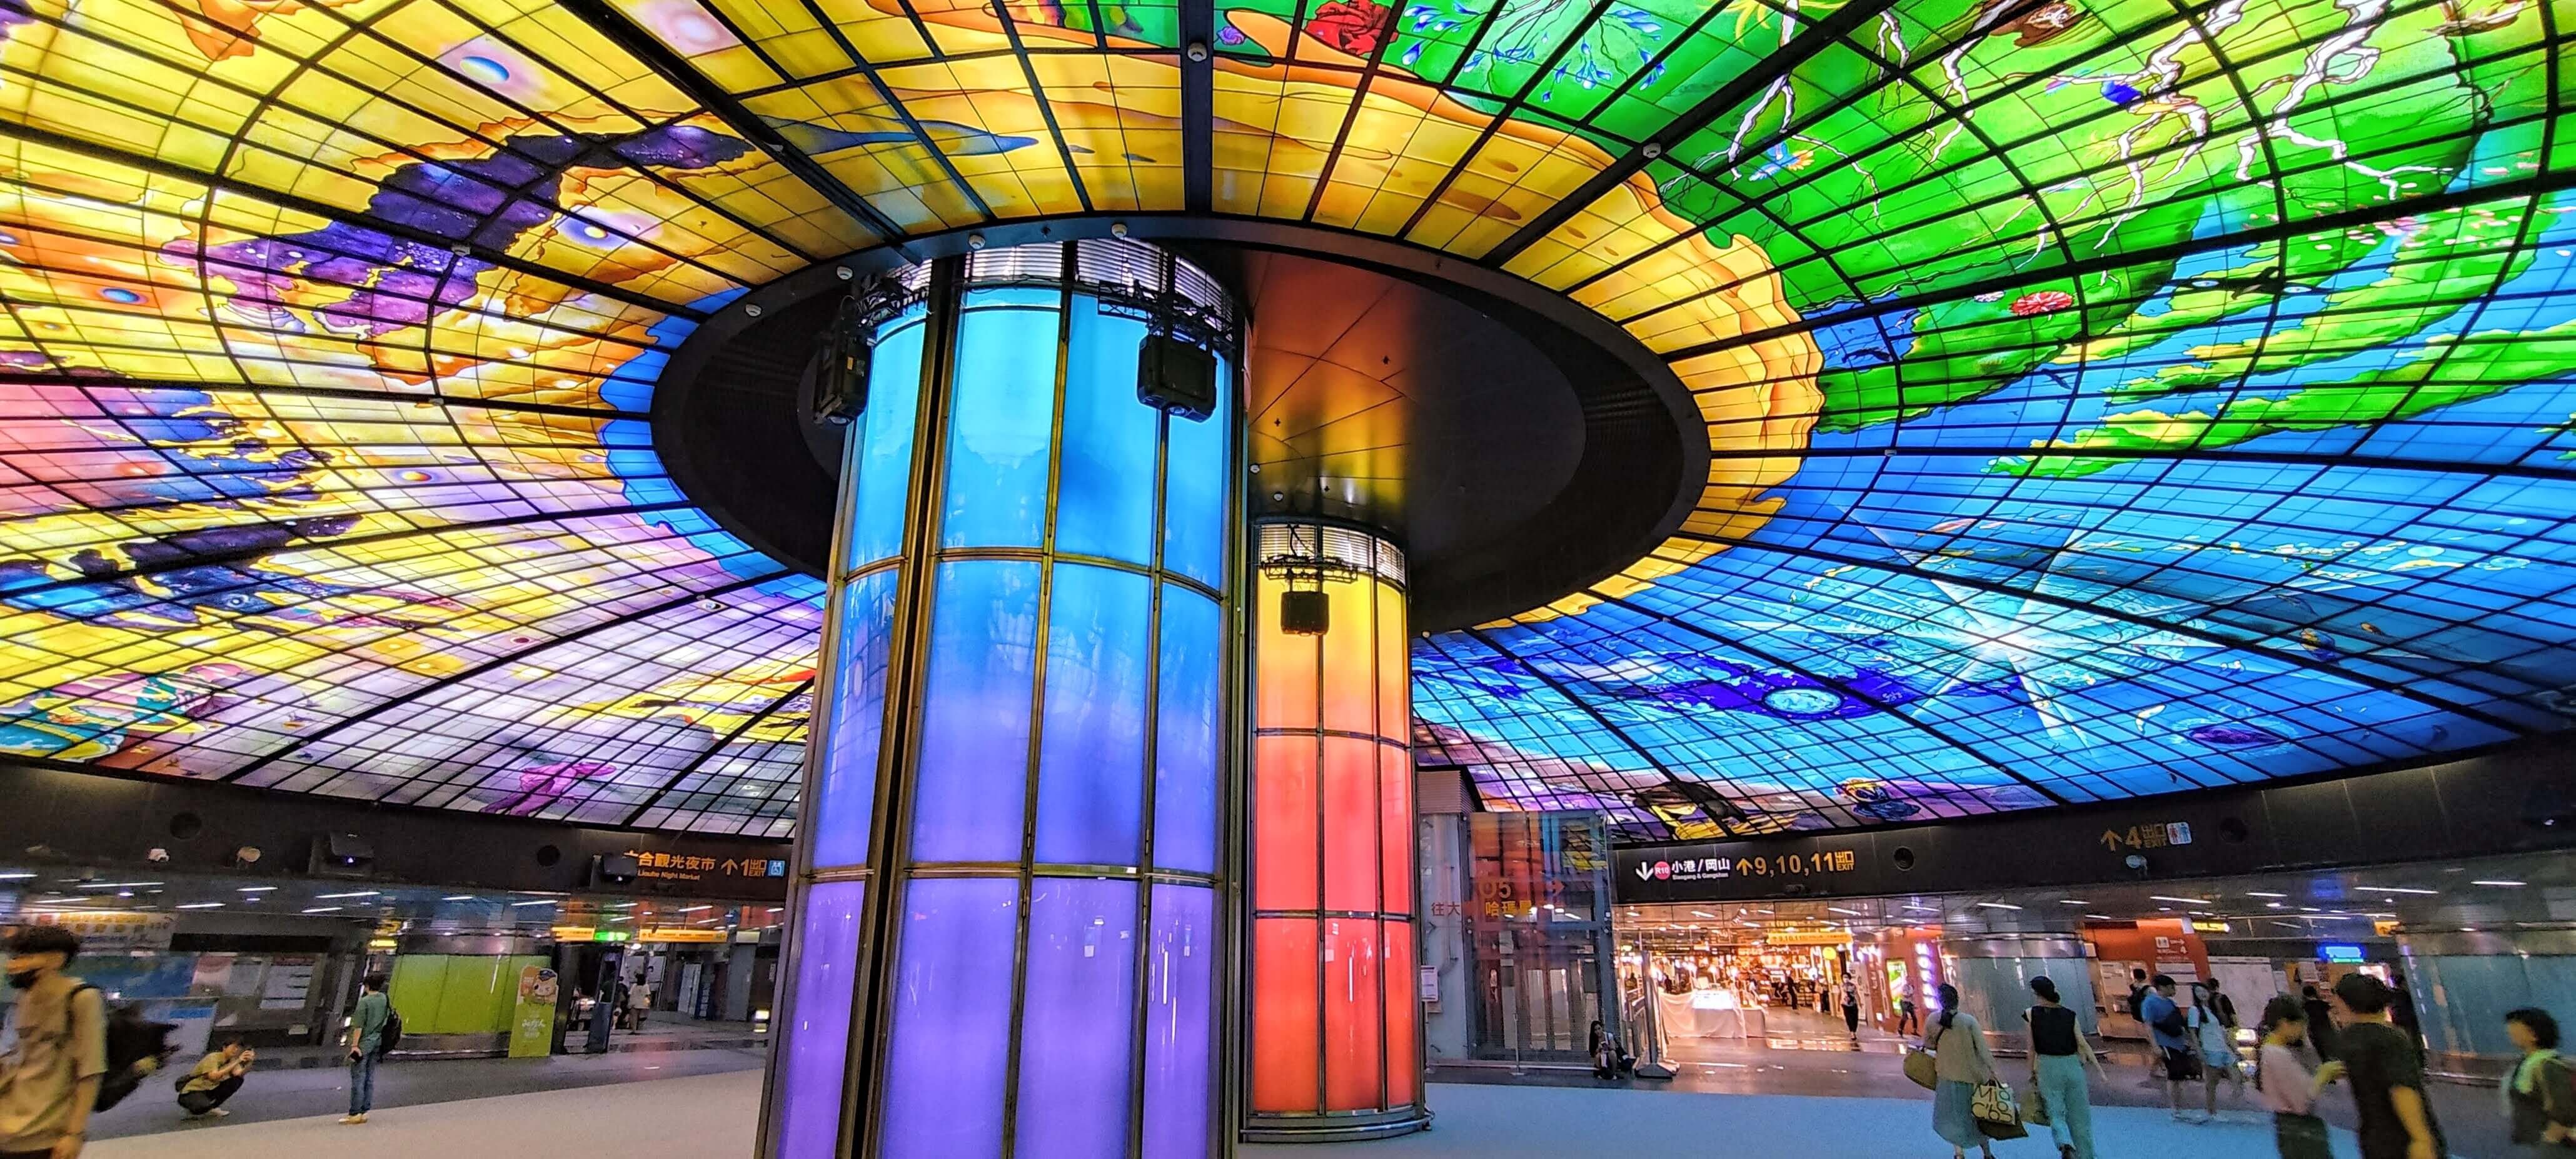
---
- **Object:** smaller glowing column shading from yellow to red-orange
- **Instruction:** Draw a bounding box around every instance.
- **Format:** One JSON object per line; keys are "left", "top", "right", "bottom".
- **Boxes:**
{"left": 1244, "top": 520, "right": 1430, "bottom": 1141}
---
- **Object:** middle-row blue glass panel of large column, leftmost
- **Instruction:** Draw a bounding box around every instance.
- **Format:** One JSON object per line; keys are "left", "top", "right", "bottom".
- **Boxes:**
{"left": 814, "top": 566, "right": 899, "bottom": 868}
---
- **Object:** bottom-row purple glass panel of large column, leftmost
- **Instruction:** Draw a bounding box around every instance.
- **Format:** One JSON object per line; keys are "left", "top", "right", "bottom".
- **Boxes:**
{"left": 775, "top": 881, "right": 868, "bottom": 1154}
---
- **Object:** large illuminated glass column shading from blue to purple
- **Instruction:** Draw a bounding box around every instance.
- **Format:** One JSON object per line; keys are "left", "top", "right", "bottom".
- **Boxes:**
{"left": 763, "top": 239, "right": 1242, "bottom": 1159}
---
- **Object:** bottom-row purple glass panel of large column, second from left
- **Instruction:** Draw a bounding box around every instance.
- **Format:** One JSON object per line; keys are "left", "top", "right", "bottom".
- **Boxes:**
{"left": 875, "top": 878, "right": 1020, "bottom": 1159}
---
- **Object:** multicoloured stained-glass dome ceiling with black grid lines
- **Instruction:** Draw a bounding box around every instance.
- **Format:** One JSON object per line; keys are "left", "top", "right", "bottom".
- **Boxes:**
{"left": 0, "top": 0, "right": 2576, "bottom": 837}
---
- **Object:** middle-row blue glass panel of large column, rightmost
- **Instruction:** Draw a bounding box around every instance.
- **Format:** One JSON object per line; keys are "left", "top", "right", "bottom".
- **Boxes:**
{"left": 1154, "top": 585, "right": 1226, "bottom": 873}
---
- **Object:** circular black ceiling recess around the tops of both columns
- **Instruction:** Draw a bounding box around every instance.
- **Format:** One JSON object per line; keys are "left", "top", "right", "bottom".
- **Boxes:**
{"left": 652, "top": 224, "right": 1708, "bottom": 631}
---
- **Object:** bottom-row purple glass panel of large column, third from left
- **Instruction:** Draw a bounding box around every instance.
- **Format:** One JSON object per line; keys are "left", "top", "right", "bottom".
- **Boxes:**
{"left": 1012, "top": 878, "right": 1136, "bottom": 1159}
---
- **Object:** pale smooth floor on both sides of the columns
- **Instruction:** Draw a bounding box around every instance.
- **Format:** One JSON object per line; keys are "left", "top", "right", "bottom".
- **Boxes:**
{"left": 88, "top": 1071, "right": 2370, "bottom": 1159}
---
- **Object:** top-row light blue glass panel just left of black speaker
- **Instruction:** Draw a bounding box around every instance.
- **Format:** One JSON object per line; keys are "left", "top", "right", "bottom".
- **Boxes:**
{"left": 1056, "top": 296, "right": 1162, "bottom": 564}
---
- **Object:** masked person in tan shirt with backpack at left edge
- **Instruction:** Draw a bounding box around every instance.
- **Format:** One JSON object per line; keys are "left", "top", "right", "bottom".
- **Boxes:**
{"left": 0, "top": 925, "right": 108, "bottom": 1159}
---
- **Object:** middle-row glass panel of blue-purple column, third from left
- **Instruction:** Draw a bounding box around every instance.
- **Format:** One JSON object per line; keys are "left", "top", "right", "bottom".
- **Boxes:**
{"left": 1038, "top": 564, "right": 1152, "bottom": 865}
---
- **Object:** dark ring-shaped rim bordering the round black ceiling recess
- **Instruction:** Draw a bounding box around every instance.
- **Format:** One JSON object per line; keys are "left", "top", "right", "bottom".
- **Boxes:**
{"left": 652, "top": 214, "right": 1711, "bottom": 626}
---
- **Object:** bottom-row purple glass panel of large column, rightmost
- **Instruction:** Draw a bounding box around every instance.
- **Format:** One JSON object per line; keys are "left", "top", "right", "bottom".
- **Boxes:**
{"left": 1144, "top": 886, "right": 1216, "bottom": 1159}
